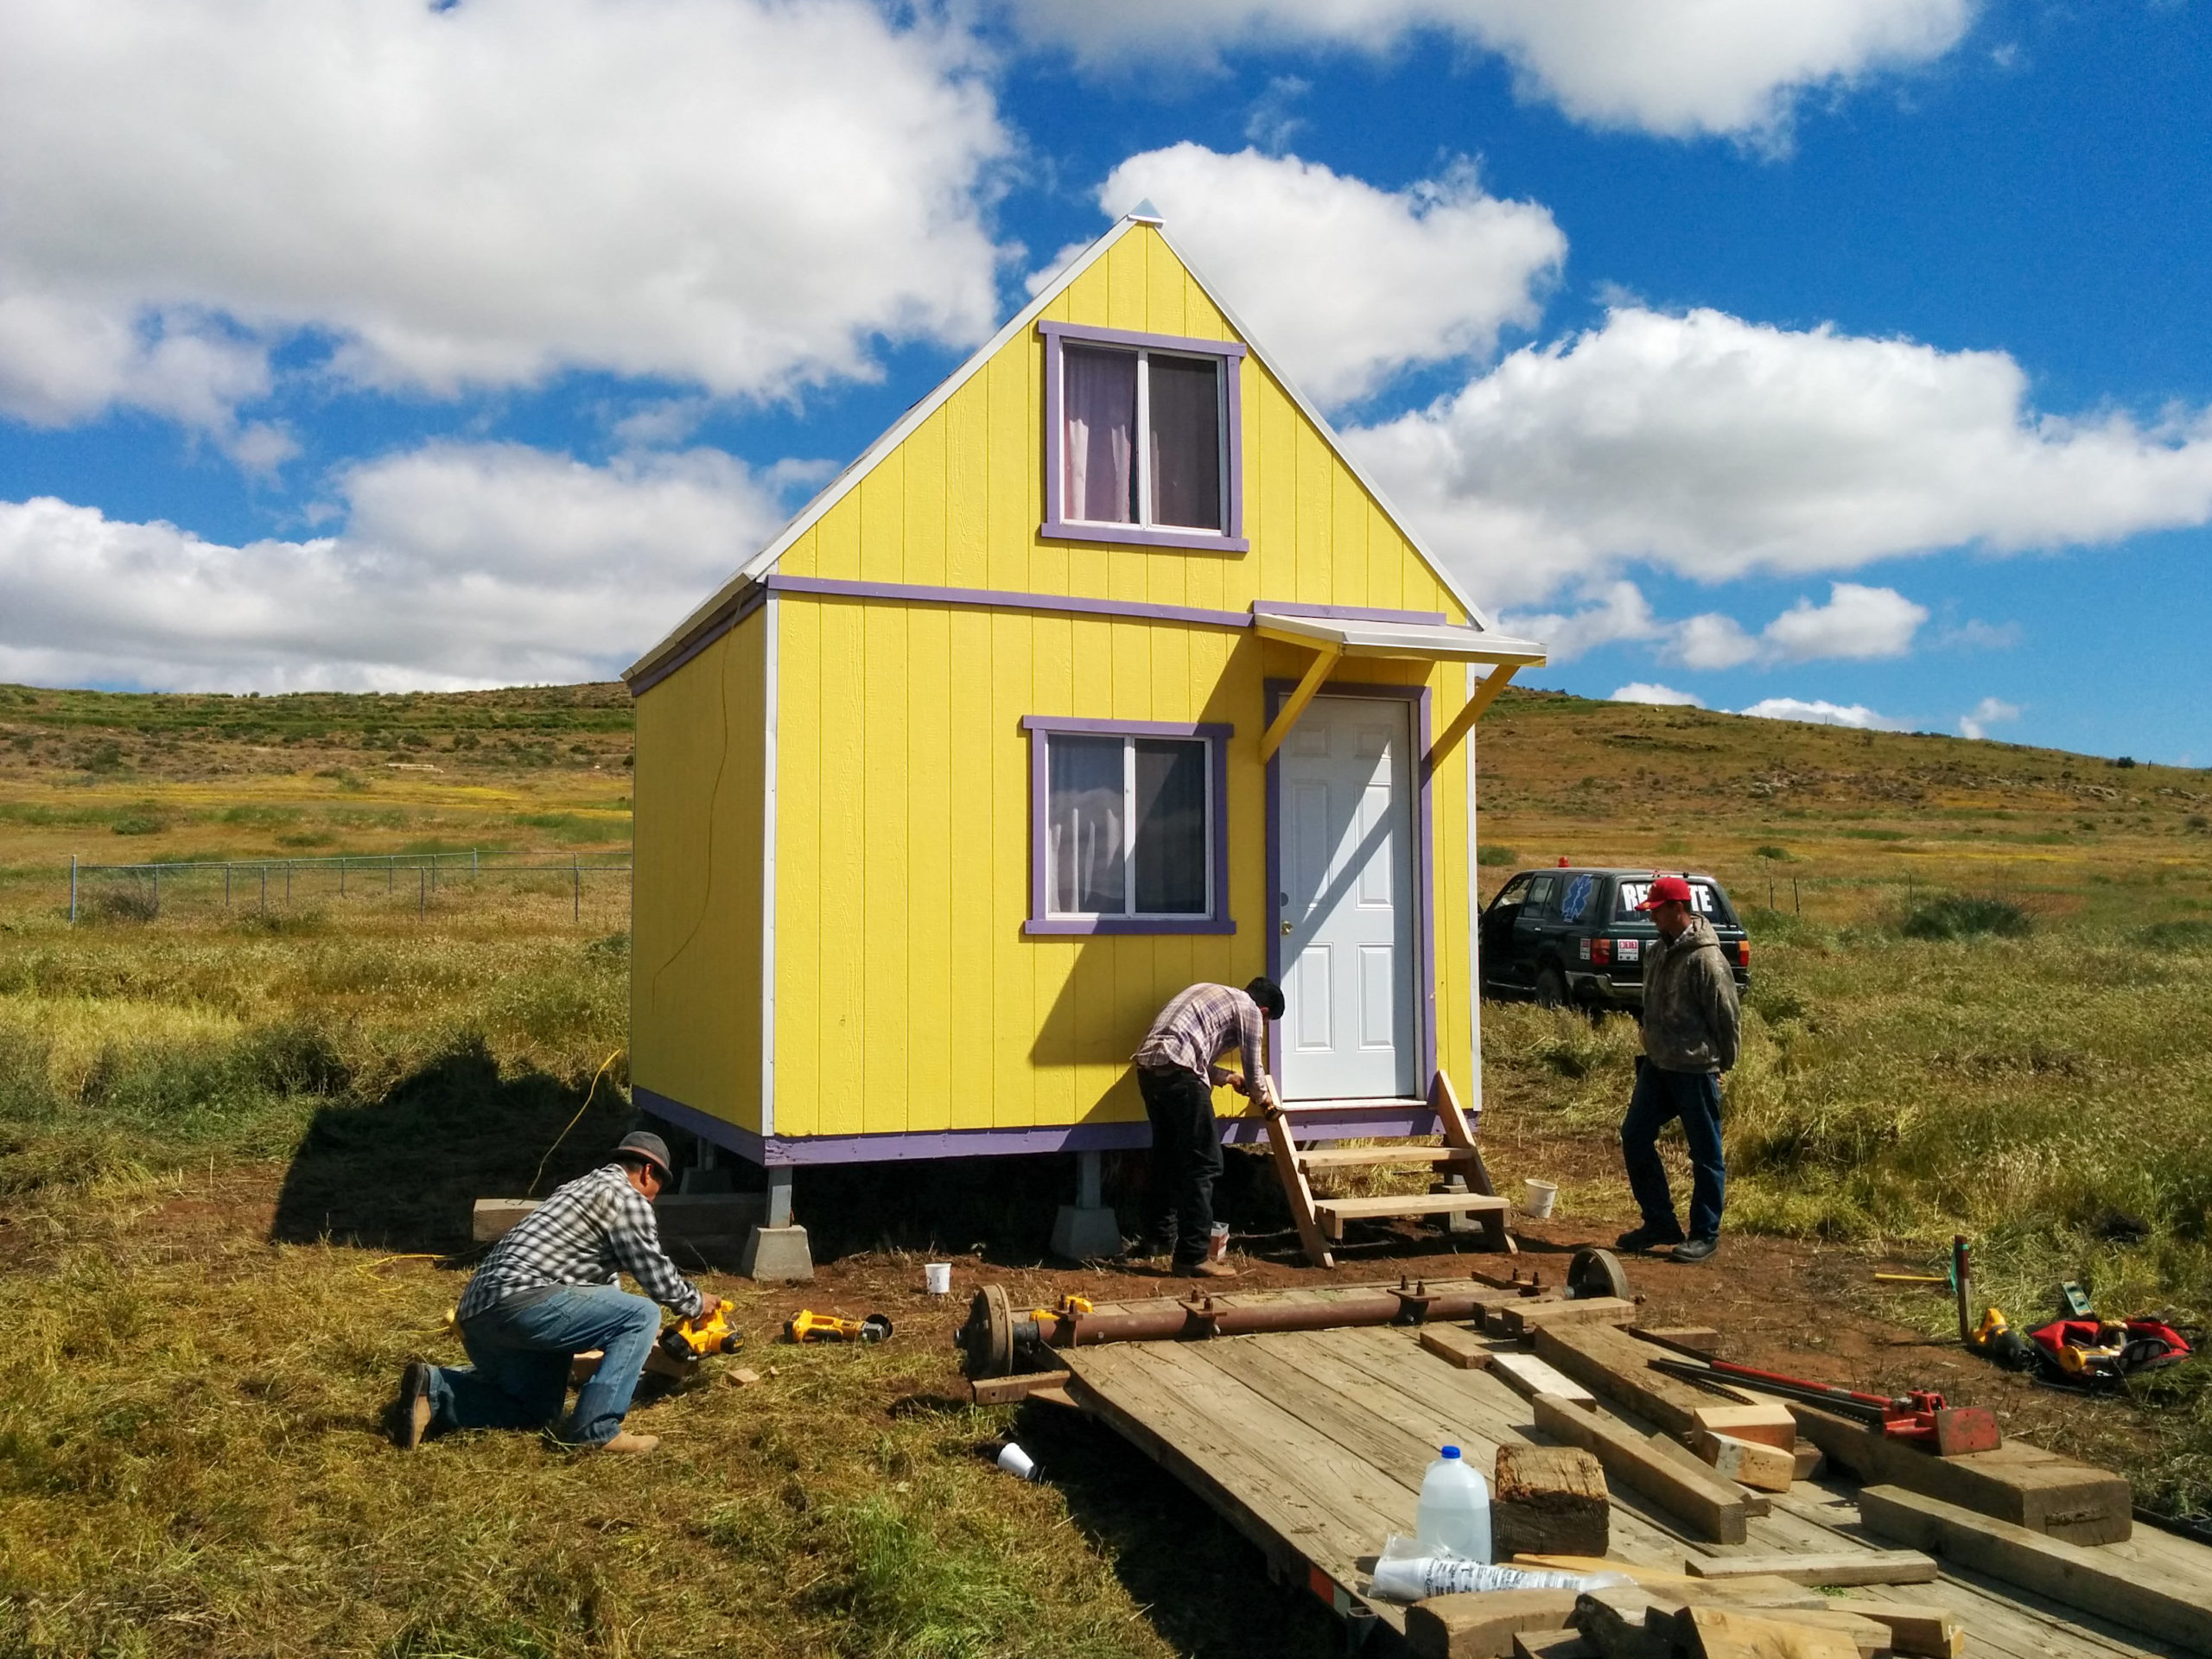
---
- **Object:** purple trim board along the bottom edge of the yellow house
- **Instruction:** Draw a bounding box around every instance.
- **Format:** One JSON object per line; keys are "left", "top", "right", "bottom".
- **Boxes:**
{"left": 631, "top": 1086, "right": 1435, "bottom": 1168}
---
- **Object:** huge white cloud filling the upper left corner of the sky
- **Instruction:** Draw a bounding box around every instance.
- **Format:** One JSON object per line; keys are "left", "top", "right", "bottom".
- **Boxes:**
{"left": 0, "top": 0, "right": 1011, "bottom": 448}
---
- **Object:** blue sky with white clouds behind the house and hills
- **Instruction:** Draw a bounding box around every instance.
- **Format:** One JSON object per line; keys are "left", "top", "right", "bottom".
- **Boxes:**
{"left": 0, "top": 0, "right": 2212, "bottom": 763}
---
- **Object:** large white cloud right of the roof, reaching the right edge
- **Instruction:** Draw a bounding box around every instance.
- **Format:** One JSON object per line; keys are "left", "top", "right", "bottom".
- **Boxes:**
{"left": 1344, "top": 308, "right": 2212, "bottom": 606}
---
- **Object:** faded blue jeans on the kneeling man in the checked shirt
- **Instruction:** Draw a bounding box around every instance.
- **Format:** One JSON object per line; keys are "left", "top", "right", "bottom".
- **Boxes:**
{"left": 429, "top": 1285, "right": 661, "bottom": 1446}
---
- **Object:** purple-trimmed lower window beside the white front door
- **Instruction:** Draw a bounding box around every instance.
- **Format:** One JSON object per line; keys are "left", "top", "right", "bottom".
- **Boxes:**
{"left": 1022, "top": 716, "right": 1234, "bottom": 933}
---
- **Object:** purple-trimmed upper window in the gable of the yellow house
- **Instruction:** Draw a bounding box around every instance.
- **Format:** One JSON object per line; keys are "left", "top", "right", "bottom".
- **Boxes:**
{"left": 1039, "top": 323, "right": 1245, "bottom": 553}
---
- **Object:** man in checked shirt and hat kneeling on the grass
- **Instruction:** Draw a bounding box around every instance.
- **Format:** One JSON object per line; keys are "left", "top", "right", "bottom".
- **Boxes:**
{"left": 394, "top": 1133, "right": 723, "bottom": 1451}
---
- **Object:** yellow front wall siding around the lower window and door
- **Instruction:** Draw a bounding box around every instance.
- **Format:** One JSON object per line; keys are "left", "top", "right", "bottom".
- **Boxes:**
{"left": 769, "top": 595, "right": 1469, "bottom": 1135}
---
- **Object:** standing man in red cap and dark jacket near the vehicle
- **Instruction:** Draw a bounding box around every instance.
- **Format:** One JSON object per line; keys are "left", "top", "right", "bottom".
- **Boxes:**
{"left": 1619, "top": 876, "right": 1741, "bottom": 1261}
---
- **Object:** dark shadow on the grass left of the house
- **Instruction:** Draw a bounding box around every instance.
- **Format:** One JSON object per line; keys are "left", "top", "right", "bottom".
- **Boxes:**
{"left": 270, "top": 1039, "right": 637, "bottom": 1255}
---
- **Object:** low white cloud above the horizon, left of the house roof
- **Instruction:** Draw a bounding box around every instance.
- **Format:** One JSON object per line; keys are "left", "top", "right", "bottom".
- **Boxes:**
{"left": 0, "top": 445, "right": 783, "bottom": 690}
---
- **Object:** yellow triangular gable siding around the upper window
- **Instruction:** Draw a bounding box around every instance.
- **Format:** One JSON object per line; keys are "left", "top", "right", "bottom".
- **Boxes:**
{"left": 777, "top": 226, "right": 1465, "bottom": 621}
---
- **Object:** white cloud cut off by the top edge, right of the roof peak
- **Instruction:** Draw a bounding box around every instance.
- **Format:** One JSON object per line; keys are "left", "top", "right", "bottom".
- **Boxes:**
{"left": 1000, "top": 0, "right": 1975, "bottom": 137}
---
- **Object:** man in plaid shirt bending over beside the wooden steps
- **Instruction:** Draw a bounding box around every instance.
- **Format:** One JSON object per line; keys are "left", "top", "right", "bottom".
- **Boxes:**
{"left": 1135, "top": 980, "right": 1283, "bottom": 1279}
